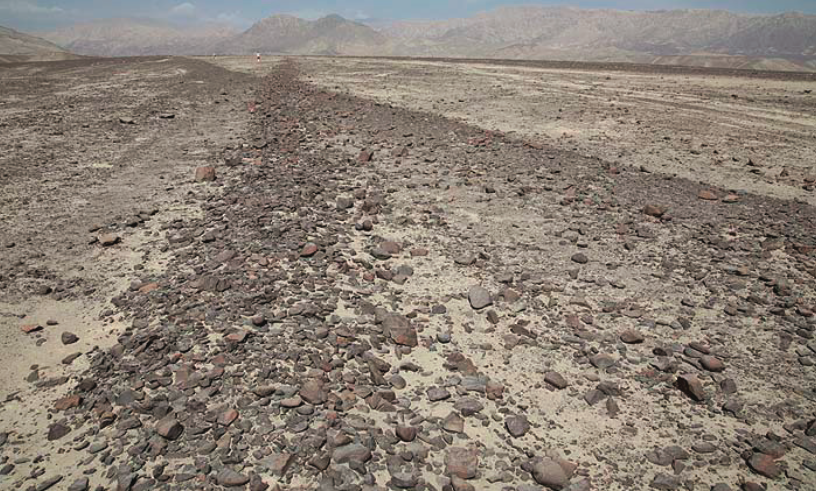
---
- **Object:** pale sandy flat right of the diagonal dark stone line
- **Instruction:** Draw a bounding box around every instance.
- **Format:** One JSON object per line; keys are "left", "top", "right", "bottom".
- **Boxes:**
{"left": 278, "top": 57, "right": 816, "bottom": 203}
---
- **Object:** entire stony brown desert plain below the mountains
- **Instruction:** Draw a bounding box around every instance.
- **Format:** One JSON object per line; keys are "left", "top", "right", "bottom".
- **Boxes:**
{"left": 0, "top": 57, "right": 816, "bottom": 491}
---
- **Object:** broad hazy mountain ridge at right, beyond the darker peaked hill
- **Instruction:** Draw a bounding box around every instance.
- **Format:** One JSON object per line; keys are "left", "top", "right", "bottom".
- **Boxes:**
{"left": 381, "top": 6, "right": 816, "bottom": 61}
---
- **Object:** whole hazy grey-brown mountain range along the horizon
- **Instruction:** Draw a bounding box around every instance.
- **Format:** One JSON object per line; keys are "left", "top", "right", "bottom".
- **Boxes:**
{"left": 1, "top": 6, "right": 816, "bottom": 70}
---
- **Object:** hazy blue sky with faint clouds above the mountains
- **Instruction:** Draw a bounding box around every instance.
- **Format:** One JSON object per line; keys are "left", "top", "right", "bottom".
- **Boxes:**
{"left": 0, "top": 0, "right": 816, "bottom": 31}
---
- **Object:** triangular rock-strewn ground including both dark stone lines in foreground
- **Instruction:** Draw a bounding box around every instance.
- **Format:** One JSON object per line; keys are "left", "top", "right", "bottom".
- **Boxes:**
{"left": 0, "top": 60, "right": 816, "bottom": 491}
